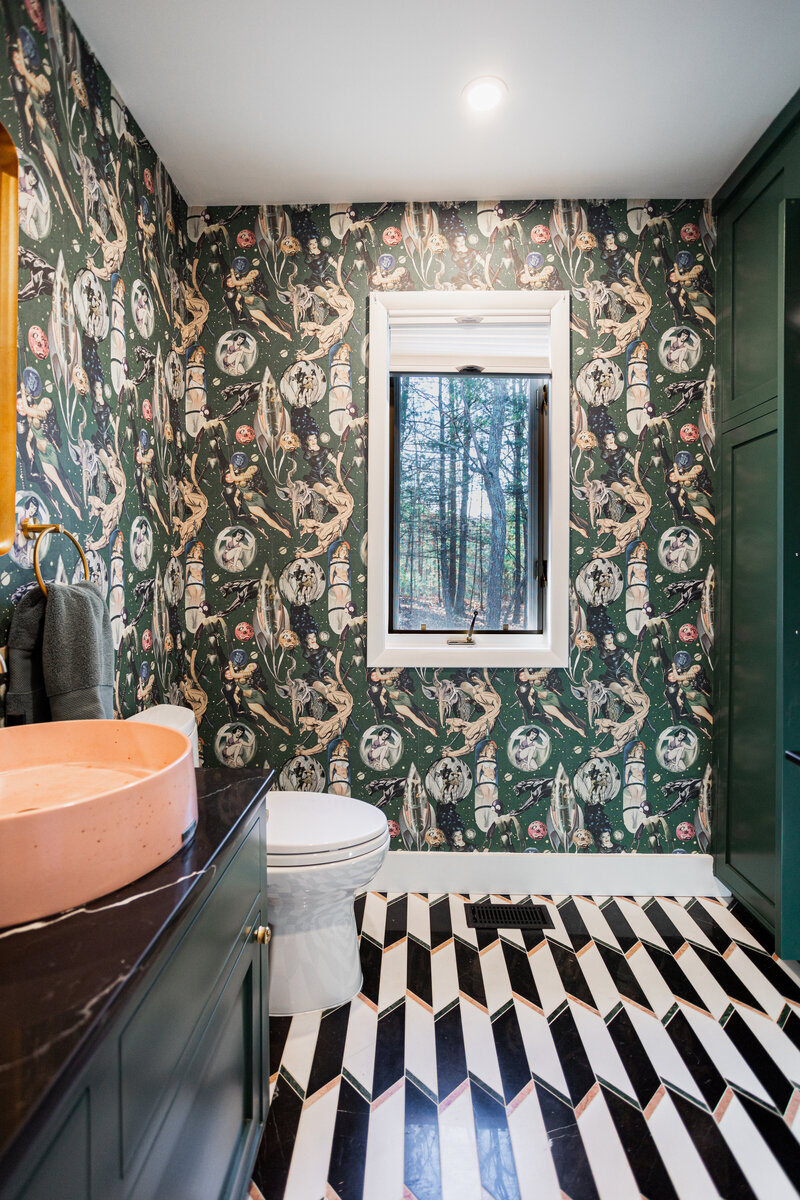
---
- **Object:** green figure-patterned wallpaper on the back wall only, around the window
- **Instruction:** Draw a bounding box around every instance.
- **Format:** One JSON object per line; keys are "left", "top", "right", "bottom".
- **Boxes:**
{"left": 184, "top": 199, "right": 715, "bottom": 853}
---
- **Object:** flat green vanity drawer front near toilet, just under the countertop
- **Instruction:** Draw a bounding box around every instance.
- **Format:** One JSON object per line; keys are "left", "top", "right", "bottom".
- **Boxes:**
{"left": 119, "top": 820, "right": 264, "bottom": 1174}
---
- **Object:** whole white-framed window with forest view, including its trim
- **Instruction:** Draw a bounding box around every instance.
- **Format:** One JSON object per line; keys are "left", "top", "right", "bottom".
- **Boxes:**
{"left": 367, "top": 292, "right": 570, "bottom": 666}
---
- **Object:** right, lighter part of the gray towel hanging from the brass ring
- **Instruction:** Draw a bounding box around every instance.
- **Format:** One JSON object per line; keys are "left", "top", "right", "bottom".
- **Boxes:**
{"left": 42, "top": 580, "right": 114, "bottom": 721}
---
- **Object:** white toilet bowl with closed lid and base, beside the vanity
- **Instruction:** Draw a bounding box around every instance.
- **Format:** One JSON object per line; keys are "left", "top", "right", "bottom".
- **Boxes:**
{"left": 266, "top": 792, "right": 389, "bottom": 1016}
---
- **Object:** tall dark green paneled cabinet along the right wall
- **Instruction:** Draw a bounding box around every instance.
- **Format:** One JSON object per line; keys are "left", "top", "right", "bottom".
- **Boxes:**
{"left": 714, "top": 94, "right": 800, "bottom": 959}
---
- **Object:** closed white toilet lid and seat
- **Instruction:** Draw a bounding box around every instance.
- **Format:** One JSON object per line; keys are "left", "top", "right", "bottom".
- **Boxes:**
{"left": 266, "top": 792, "right": 387, "bottom": 860}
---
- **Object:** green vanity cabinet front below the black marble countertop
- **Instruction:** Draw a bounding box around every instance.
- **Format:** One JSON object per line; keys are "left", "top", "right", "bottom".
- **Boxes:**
{"left": 0, "top": 802, "right": 269, "bottom": 1200}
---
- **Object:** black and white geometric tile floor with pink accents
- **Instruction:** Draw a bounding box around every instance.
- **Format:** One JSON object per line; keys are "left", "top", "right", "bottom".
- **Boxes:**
{"left": 252, "top": 893, "right": 800, "bottom": 1200}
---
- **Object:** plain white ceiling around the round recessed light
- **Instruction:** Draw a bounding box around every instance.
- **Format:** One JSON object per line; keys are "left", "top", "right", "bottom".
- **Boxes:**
{"left": 67, "top": 0, "right": 800, "bottom": 204}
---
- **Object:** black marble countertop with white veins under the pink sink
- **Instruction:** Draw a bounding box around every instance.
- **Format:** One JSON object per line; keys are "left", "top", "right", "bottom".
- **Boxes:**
{"left": 0, "top": 768, "right": 272, "bottom": 1166}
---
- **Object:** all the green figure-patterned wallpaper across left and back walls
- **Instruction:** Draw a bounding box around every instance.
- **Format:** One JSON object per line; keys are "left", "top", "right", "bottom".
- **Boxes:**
{"left": 0, "top": 0, "right": 715, "bottom": 853}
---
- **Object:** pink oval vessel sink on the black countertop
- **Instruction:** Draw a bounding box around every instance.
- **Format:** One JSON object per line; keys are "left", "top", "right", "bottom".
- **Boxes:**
{"left": 0, "top": 721, "right": 197, "bottom": 926}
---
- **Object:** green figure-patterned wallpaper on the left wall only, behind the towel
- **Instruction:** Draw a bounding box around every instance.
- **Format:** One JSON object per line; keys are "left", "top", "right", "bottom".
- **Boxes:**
{"left": 0, "top": 0, "right": 187, "bottom": 715}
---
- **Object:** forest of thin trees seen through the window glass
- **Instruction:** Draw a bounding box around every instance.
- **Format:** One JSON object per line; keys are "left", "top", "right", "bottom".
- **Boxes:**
{"left": 390, "top": 373, "right": 548, "bottom": 634}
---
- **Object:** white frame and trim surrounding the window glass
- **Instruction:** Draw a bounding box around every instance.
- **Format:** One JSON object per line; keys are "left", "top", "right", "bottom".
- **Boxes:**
{"left": 367, "top": 292, "right": 571, "bottom": 667}
